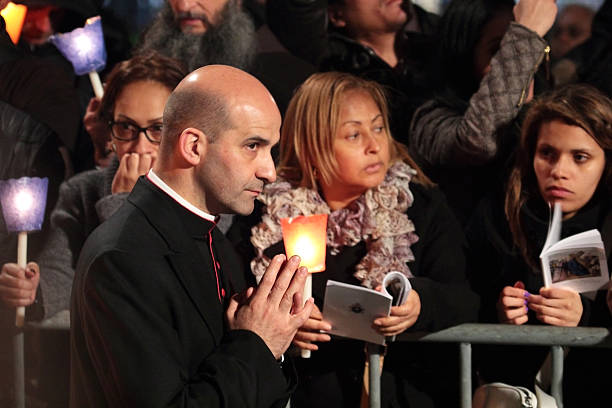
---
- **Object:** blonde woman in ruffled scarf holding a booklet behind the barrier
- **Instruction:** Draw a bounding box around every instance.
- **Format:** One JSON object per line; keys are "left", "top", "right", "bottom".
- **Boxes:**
{"left": 229, "top": 72, "right": 477, "bottom": 407}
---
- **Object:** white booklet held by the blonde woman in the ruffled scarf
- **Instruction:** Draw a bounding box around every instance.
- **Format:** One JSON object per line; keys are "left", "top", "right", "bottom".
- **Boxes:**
{"left": 323, "top": 271, "right": 412, "bottom": 345}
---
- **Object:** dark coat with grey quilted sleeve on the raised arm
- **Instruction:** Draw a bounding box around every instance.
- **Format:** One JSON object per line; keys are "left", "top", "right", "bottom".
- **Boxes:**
{"left": 409, "top": 22, "right": 547, "bottom": 224}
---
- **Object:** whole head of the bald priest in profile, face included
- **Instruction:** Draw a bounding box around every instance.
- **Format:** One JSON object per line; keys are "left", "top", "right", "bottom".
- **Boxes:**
{"left": 153, "top": 65, "right": 281, "bottom": 215}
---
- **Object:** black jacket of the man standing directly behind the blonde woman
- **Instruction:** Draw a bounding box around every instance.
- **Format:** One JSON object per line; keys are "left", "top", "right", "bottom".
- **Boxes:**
{"left": 266, "top": 0, "right": 439, "bottom": 144}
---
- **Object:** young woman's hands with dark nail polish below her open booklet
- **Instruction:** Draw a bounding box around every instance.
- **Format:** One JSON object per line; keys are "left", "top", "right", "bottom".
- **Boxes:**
{"left": 497, "top": 281, "right": 582, "bottom": 327}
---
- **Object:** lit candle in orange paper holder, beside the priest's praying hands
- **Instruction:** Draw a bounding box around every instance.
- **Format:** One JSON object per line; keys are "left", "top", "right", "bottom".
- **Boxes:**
{"left": 281, "top": 214, "right": 327, "bottom": 358}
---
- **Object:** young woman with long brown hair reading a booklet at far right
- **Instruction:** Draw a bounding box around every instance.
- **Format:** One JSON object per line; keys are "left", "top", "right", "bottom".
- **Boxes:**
{"left": 467, "top": 85, "right": 612, "bottom": 406}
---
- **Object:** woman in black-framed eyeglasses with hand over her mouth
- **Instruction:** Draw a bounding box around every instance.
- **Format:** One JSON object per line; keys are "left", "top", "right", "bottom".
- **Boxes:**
{"left": 0, "top": 53, "right": 186, "bottom": 319}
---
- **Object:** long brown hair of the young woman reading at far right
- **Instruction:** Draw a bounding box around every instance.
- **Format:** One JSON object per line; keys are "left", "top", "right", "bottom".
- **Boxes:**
{"left": 505, "top": 84, "right": 612, "bottom": 266}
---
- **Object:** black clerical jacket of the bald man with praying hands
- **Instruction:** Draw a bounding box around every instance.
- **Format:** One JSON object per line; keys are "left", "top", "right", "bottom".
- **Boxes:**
{"left": 71, "top": 178, "right": 294, "bottom": 408}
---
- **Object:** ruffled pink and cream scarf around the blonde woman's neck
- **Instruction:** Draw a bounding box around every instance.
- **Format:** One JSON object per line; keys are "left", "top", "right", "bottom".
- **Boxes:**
{"left": 251, "top": 161, "right": 419, "bottom": 288}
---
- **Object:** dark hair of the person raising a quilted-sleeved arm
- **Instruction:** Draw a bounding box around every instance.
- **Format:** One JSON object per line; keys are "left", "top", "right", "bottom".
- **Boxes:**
{"left": 433, "top": 0, "right": 514, "bottom": 105}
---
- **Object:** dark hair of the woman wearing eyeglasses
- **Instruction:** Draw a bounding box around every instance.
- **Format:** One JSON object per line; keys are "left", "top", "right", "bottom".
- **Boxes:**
{"left": 99, "top": 52, "right": 187, "bottom": 121}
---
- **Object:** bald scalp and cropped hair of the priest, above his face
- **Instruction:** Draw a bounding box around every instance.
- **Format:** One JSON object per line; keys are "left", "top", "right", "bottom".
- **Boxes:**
{"left": 160, "top": 65, "right": 278, "bottom": 154}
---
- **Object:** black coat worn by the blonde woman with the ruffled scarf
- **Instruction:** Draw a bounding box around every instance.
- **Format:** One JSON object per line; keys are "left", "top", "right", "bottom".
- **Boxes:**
{"left": 228, "top": 183, "right": 478, "bottom": 408}
